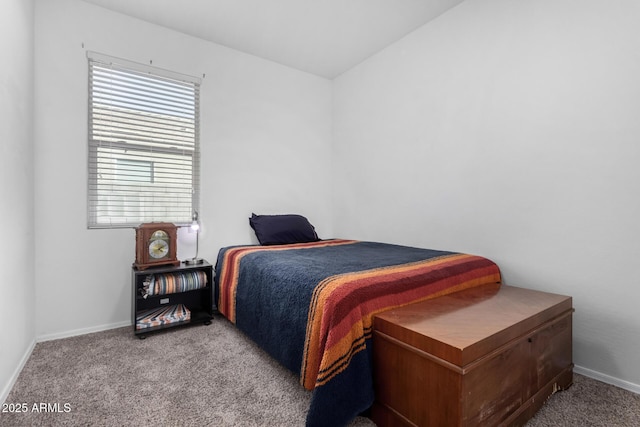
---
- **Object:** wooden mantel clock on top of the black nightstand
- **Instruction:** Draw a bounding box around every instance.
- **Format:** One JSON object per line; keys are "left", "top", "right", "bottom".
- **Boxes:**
{"left": 134, "top": 222, "right": 180, "bottom": 270}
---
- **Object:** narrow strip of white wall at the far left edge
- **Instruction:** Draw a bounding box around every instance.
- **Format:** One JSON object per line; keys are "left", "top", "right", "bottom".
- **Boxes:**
{"left": 0, "top": 0, "right": 35, "bottom": 402}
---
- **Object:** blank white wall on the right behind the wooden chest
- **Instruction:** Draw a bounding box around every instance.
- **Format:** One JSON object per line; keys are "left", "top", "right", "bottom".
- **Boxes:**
{"left": 333, "top": 0, "right": 640, "bottom": 392}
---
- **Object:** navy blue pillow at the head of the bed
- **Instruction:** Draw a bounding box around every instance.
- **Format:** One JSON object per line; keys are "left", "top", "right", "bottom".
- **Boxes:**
{"left": 249, "top": 214, "right": 320, "bottom": 245}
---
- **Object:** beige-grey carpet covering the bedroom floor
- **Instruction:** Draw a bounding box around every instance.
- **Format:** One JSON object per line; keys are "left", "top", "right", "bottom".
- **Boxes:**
{"left": 0, "top": 317, "right": 640, "bottom": 427}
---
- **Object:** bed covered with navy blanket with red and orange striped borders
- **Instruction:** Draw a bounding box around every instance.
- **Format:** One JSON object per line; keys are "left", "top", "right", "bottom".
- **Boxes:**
{"left": 215, "top": 215, "right": 500, "bottom": 426}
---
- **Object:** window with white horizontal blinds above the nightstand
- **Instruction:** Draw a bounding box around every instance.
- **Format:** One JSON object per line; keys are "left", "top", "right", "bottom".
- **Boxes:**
{"left": 88, "top": 52, "right": 200, "bottom": 228}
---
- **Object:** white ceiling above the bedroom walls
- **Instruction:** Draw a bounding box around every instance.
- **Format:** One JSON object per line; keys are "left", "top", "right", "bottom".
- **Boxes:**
{"left": 84, "top": 0, "right": 463, "bottom": 79}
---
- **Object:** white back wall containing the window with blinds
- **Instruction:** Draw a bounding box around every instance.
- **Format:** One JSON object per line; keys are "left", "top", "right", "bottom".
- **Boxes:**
{"left": 35, "top": 0, "right": 332, "bottom": 339}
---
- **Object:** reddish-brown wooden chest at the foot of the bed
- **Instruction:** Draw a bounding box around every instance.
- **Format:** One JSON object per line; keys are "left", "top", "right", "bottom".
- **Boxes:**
{"left": 371, "top": 285, "right": 573, "bottom": 427}
